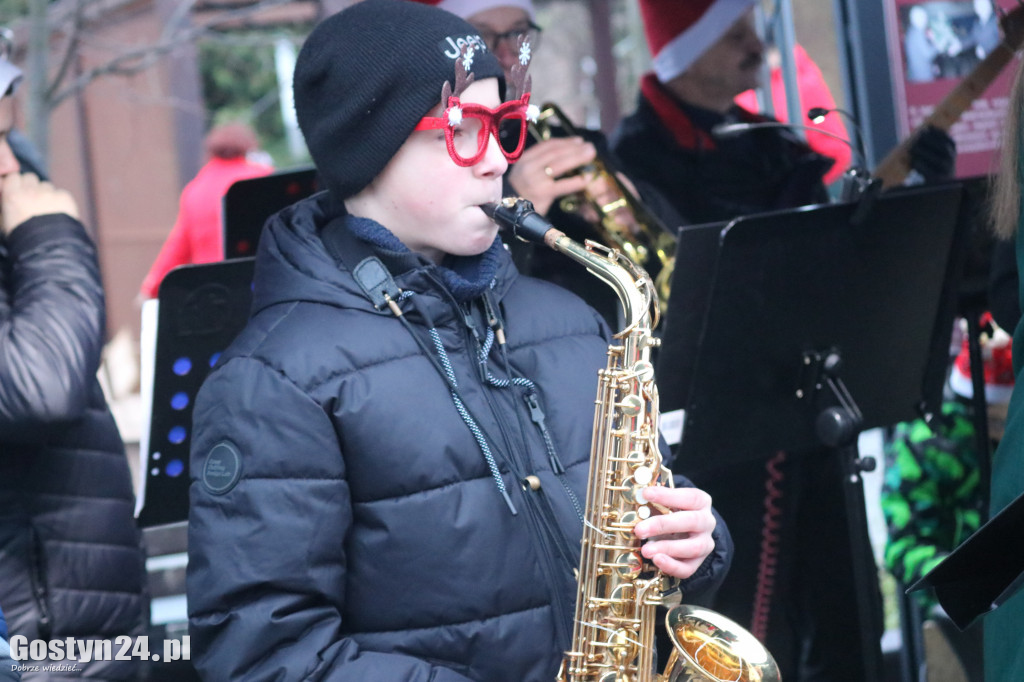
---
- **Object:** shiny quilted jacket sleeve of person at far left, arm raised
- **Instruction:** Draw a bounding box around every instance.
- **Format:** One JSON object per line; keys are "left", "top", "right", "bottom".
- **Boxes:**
{"left": 0, "top": 215, "right": 105, "bottom": 441}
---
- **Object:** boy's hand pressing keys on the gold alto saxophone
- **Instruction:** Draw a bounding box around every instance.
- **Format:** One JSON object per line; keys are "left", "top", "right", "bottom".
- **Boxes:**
{"left": 633, "top": 485, "right": 716, "bottom": 579}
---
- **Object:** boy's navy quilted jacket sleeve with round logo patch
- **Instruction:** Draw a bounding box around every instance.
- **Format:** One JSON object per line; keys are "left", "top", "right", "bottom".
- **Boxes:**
{"left": 187, "top": 357, "right": 468, "bottom": 682}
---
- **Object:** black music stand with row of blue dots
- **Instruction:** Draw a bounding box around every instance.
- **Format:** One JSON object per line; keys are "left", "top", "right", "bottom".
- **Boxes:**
{"left": 138, "top": 258, "right": 253, "bottom": 527}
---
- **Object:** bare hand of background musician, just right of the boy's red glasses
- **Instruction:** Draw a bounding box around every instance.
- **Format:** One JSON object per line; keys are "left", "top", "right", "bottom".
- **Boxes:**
{"left": 509, "top": 137, "right": 597, "bottom": 215}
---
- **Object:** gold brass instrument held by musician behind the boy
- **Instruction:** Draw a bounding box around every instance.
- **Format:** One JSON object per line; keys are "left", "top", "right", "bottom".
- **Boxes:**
{"left": 529, "top": 102, "right": 676, "bottom": 306}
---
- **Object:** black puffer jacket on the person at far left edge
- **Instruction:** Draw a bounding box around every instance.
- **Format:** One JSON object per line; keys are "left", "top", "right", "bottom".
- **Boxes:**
{"left": 0, "top": 215, "right": 148, "bottom": 680}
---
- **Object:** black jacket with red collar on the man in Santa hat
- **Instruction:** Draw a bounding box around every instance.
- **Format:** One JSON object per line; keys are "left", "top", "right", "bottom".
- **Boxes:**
{"left": 612, "top": 75, "right": 833, "bottom": 223}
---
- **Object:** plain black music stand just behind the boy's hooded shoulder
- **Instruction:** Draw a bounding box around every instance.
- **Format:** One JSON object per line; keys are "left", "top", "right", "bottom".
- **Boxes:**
{"left": 223, "top": 166, "right": 317, "bottom": 258}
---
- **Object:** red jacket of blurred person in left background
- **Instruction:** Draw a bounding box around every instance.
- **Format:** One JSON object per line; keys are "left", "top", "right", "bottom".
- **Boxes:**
{"left": 142, "top": 157, "right": 273, "bottom": 298}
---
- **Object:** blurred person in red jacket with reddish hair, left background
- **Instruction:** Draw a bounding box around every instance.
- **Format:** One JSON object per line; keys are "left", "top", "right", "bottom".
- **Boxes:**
{"left": 142, "top": 123, "right": 273, "bottom": 298}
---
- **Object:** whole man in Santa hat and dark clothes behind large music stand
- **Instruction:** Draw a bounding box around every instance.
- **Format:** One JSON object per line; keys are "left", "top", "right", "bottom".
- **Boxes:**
{"left": 613, "top": 0, "right": 955, "bottom": 682}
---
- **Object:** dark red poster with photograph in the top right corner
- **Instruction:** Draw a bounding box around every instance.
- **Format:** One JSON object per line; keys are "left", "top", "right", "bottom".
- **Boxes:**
{"left": 886, "top": 0, "right": 1024, "bottom": 177}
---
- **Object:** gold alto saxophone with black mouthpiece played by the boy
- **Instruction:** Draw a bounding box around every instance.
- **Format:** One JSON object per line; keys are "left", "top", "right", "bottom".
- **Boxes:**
{"left": 481, "top": 199, "right": 780, "bottom": 682}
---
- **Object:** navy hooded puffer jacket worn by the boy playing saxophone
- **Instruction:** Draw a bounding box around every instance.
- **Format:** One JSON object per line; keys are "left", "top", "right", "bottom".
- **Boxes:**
{"left": 187, "top": 196, "right": 730, "bottom": 682}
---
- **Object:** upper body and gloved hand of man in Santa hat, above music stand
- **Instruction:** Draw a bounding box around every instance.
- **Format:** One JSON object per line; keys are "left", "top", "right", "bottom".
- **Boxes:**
{"left": 612, "top": 0, "right": 955, "bottom": 223}
